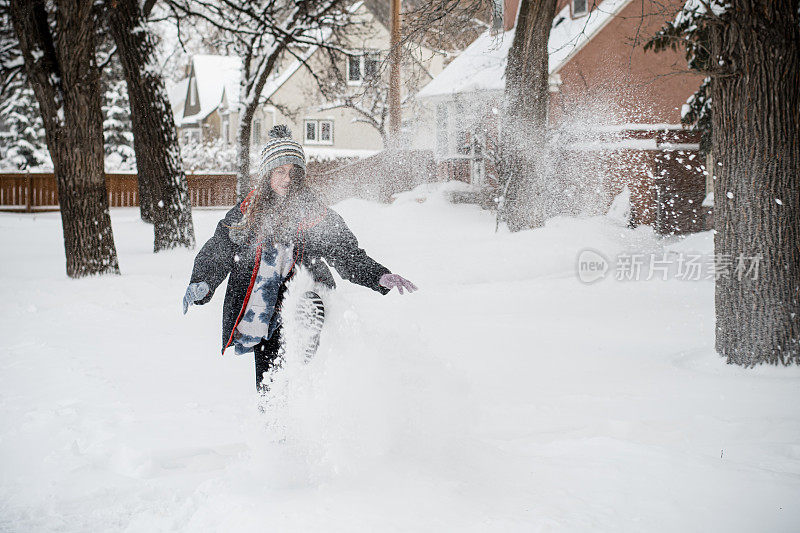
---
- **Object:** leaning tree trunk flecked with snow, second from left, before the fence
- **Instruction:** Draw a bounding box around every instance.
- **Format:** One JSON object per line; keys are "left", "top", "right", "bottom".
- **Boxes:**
{"left": 107, "top": 0, "right": 194, "bottom": 252}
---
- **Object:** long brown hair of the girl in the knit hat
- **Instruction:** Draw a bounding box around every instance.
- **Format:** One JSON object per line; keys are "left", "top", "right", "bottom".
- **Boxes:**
{"left": 228, "top": 165, "right": 324, "bottom": 245}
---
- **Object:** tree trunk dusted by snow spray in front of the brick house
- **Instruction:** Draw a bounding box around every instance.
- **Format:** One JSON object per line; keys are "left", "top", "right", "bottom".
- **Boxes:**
{"left": 500, "top": 0, "right": 556, "bottom": 231}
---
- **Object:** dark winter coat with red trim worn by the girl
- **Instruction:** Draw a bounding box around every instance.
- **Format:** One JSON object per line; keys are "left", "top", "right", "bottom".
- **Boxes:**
{"left": 190, "top": 196, "right": 390, "bottom": 353}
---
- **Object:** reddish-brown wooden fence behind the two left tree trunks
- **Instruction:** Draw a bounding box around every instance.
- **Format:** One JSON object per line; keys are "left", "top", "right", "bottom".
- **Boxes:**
{"left": 0, "top": 172, "right": 236, "bottom": 212}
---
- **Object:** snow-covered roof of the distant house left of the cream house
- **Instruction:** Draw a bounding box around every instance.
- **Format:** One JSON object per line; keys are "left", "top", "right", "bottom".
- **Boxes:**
{"left": 181, "top": 55, "right": 242, "bottom": 123}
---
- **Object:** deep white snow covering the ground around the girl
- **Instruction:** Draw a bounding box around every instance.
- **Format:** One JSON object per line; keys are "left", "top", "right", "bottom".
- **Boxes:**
{"left": 0, "top": 186, "right": 800, "bottom": 532}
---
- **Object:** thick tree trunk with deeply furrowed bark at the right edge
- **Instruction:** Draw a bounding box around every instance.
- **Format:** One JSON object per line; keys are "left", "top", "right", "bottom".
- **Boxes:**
{"left": 712, "top": 0, "right": 800, "bottom": 366}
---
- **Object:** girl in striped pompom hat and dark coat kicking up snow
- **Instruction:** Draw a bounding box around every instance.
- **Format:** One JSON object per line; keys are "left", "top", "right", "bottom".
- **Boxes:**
{"left": 183, "top": 126, "right": 417, "bottom": 391}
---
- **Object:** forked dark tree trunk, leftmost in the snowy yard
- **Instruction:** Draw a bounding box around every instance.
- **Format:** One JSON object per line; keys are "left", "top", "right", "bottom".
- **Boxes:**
{"left": 9, "top": 0, "right": 119, "bottom": 278}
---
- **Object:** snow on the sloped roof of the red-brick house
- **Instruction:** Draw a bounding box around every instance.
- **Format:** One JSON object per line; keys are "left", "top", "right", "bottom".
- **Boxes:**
{"left": 417, "top": 0, "right": 632, "bottom": 98}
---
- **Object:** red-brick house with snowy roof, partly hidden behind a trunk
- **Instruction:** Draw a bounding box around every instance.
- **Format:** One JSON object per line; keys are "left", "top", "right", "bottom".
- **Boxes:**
{"left": 418, "top": 0, "right": 710, "bottom": 233}
